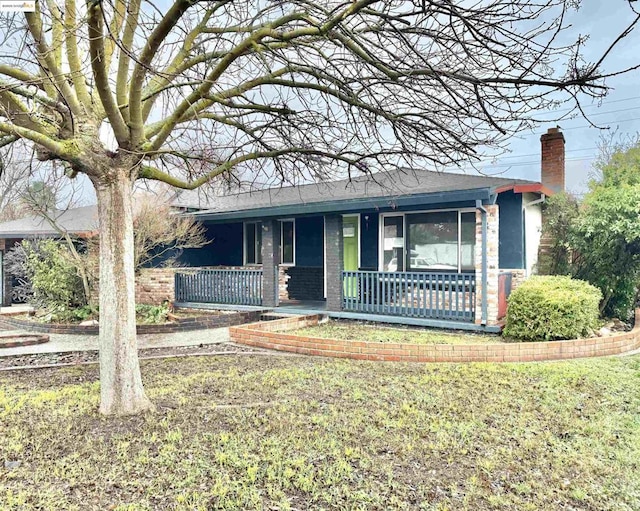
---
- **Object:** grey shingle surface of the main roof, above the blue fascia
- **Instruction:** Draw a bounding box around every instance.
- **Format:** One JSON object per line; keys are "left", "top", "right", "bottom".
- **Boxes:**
{"left": 194, "top": 169, "right": 536, "bottom": 214}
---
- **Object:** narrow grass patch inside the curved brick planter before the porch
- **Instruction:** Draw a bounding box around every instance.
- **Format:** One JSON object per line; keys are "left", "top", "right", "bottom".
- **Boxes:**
{"left": 287, "top": 320, "right": 503, "bottom": 344}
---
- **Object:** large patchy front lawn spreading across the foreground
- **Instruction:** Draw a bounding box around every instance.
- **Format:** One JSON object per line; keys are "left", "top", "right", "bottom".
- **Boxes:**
{"left": 0, "top": 356, "right": 640, "bottom": 511}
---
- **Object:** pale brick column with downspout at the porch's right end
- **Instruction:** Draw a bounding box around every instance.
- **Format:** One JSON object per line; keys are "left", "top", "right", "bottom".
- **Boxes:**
{"left": 475, "top": 204, "right": 500, "bottom": 325}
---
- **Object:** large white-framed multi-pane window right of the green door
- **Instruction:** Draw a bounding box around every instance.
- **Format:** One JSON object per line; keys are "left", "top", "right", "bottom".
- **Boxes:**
{"left": 381, "top": 211, "right": 476, "bottom": 272}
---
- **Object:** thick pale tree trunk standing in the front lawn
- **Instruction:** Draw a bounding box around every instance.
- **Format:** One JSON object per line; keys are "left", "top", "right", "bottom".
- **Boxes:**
{"left": 94, "top": 169, "right": 153, "bottom": 415}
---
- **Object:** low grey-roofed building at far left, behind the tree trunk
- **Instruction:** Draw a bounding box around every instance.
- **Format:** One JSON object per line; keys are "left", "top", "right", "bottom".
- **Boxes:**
{"left": 0, "top": 206, "right": 98, "bottom": 305}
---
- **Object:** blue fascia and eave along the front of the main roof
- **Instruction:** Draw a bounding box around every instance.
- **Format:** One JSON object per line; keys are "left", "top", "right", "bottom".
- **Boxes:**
{"left": 191, "top": 188, "right": 495, "bottom": 222}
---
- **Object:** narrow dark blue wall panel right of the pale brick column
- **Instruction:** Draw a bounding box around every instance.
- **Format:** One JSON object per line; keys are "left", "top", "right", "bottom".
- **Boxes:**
{"left": 497, "top": 191, "right": 524, "bottom": 269}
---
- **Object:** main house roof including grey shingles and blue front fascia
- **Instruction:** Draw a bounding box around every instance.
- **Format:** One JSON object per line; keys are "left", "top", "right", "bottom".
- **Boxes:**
{"left": 195, "top": 169, "right": 540, "bottom": 220}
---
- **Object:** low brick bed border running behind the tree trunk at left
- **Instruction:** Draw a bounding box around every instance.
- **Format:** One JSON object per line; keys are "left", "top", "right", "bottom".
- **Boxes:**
{"left": 0, "top": 310, "right": 265, "bottom": 335}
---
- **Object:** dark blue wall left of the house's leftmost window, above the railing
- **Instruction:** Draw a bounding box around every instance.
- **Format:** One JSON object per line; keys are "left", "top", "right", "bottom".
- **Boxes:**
{"left": 179, "top": 222, "right": 243, "bottom": 266}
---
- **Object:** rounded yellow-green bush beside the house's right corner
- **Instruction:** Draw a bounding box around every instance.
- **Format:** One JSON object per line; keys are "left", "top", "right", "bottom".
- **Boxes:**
{"left": 503, "top": 276, "right": 602, "bottom": 341}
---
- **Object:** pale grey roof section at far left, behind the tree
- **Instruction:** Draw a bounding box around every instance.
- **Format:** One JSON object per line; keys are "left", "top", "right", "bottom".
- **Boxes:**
{"left": 0, "top": 205, "right": 98, "bottom": 239}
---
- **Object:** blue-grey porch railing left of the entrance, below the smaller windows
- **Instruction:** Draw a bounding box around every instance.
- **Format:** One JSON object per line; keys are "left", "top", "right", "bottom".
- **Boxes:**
{"left": 175, "top": 269, "right": 262, "bottom": 305}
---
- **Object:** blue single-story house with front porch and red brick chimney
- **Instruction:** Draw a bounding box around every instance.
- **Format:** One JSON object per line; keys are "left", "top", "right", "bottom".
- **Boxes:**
{"left": 175, "top": 128, "right": 564, "bottom": 328}
